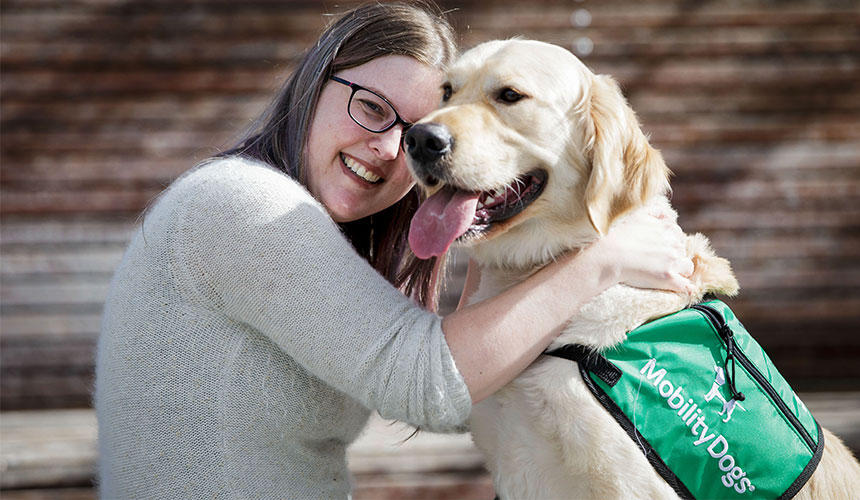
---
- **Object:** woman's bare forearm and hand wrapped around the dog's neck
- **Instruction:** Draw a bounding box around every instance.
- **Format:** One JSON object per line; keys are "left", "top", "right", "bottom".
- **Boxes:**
{"left": 442, "top": 209, "right": 693, "bottom": 402}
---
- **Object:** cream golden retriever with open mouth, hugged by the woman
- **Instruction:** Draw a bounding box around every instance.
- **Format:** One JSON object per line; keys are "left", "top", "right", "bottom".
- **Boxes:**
{"left": 405, "top": 40, "right": 860, "bottom": 499}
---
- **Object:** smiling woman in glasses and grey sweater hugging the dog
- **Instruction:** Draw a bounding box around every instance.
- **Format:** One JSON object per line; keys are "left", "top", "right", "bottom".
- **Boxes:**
{"left": 95, "top": 4, "right": 692, "bottom": 498}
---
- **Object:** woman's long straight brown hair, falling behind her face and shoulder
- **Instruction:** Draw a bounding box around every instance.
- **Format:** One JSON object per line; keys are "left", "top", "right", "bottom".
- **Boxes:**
{"left": 221, "top": 2, "right": 456, "bottom": 309}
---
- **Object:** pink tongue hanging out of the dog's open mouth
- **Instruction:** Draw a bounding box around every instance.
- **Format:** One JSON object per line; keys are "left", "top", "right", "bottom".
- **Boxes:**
{"left": 409, "top": 187, "right": 479, "bottom": 259}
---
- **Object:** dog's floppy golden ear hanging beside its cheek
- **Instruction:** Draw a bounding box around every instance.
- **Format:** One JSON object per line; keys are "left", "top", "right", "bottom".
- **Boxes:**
{"left": 583, "top": 75, "right": 669, "bottom": 234}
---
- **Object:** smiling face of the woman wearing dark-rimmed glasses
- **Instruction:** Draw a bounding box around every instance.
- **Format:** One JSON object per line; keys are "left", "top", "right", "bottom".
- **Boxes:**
{"left": 305, "top": 56, "right": 442, "bottom": 222}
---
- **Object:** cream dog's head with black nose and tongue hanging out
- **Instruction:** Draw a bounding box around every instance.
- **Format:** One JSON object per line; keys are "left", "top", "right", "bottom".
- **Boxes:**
{"left": 404, "top": 40, "right": 669, "bottom": 268}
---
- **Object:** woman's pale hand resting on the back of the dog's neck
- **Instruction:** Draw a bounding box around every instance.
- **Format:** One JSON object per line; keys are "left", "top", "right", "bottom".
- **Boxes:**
{"left": 591, "top": 207, "right": 693, "bottom": 293}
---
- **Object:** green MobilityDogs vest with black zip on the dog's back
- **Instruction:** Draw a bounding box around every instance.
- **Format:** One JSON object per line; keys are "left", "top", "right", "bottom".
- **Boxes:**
{"left": 547, "top": 300, "right": 824, "bottom": 499}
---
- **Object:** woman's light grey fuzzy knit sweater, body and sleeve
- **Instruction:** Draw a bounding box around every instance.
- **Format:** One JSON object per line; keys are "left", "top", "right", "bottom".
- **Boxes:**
{"left": 95, "top": 158, "right": 471, "bottom": 499}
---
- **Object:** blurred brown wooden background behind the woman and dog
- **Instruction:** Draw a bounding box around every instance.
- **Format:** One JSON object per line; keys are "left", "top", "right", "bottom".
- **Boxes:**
{"left": 0, "top": 0, "right": 860, "bottom": 499}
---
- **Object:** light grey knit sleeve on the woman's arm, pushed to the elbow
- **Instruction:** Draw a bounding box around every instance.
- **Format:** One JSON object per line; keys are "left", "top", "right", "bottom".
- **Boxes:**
{"left": 163, "top": 158, "right": 471, "bottom": 431}
